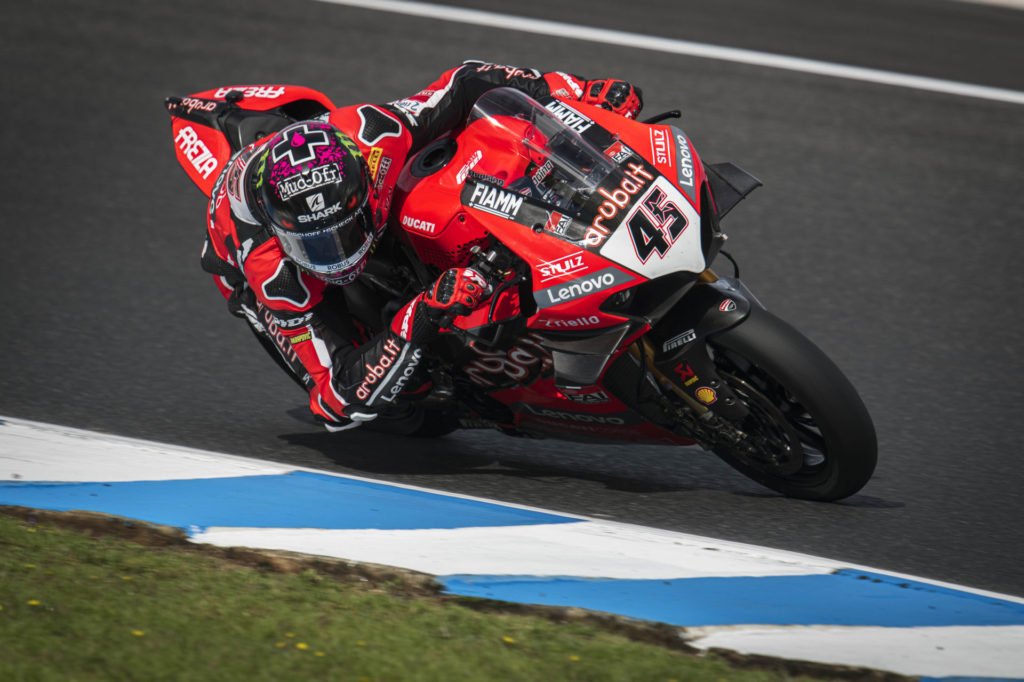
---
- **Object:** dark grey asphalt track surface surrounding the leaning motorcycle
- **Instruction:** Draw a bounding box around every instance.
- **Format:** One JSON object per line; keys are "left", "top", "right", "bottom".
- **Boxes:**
{"left": 0, "top": 0, "right": 1024, "bottom": 595}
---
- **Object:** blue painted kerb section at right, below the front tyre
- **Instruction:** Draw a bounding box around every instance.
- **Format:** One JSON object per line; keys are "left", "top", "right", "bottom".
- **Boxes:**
{"left": 437, "top": 569, "right": 1024, "bottom": 628}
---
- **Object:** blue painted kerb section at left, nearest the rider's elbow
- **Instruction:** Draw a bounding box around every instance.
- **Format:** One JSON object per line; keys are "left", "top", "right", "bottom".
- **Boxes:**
{"left": 0, "top": 471, "right": 578, "bottom": 532}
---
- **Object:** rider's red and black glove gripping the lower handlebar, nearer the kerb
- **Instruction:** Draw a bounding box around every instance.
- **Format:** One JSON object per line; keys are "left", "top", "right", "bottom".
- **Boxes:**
{"left": 391, "top": 267, "right": 489, "bottom": 344}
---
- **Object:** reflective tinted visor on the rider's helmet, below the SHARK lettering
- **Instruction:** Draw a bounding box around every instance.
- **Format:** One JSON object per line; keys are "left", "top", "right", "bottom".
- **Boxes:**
{"left": 270, "top": 197, "right": 374, "bottom": 279}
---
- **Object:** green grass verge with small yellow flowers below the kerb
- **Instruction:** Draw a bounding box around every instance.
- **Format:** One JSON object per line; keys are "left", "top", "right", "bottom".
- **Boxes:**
{"left": 0, "top": 515, "right": 827, "bottom": 682}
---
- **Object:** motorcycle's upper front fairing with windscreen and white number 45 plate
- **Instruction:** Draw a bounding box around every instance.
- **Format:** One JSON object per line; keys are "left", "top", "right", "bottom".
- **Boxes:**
{"left": 464, "top": 88, "right": 708, "bottom": 280}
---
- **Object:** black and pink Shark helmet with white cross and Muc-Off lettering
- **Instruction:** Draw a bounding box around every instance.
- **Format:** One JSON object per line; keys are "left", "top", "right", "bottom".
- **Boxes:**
{"left": 250, "top": 121, "right": 377, "bottom": 285}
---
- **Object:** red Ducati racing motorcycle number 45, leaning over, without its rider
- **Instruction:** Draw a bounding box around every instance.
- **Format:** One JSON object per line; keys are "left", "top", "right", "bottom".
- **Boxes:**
{"left": 167, "top": 86, "right": 877, "bottom": 501}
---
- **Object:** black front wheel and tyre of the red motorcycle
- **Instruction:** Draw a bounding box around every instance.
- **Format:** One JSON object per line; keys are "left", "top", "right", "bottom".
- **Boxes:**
{"left": 709, "top": 306, "right": 878, "bottom": 501}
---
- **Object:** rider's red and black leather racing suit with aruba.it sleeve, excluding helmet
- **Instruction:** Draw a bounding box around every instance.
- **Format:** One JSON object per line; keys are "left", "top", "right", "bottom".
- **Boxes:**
{"left": 203, "top": 61, "right": 639, "bottom": 428}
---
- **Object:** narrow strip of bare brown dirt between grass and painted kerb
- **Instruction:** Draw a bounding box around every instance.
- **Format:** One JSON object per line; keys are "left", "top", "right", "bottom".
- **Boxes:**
{"left": 0, "top": 506, "right": 916, "bottom": 682}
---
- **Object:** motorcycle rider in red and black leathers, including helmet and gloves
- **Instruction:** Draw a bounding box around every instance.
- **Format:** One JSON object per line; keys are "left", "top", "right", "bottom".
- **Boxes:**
{"left": 202, "top": 61, "right": 642, "bottom": 430}
